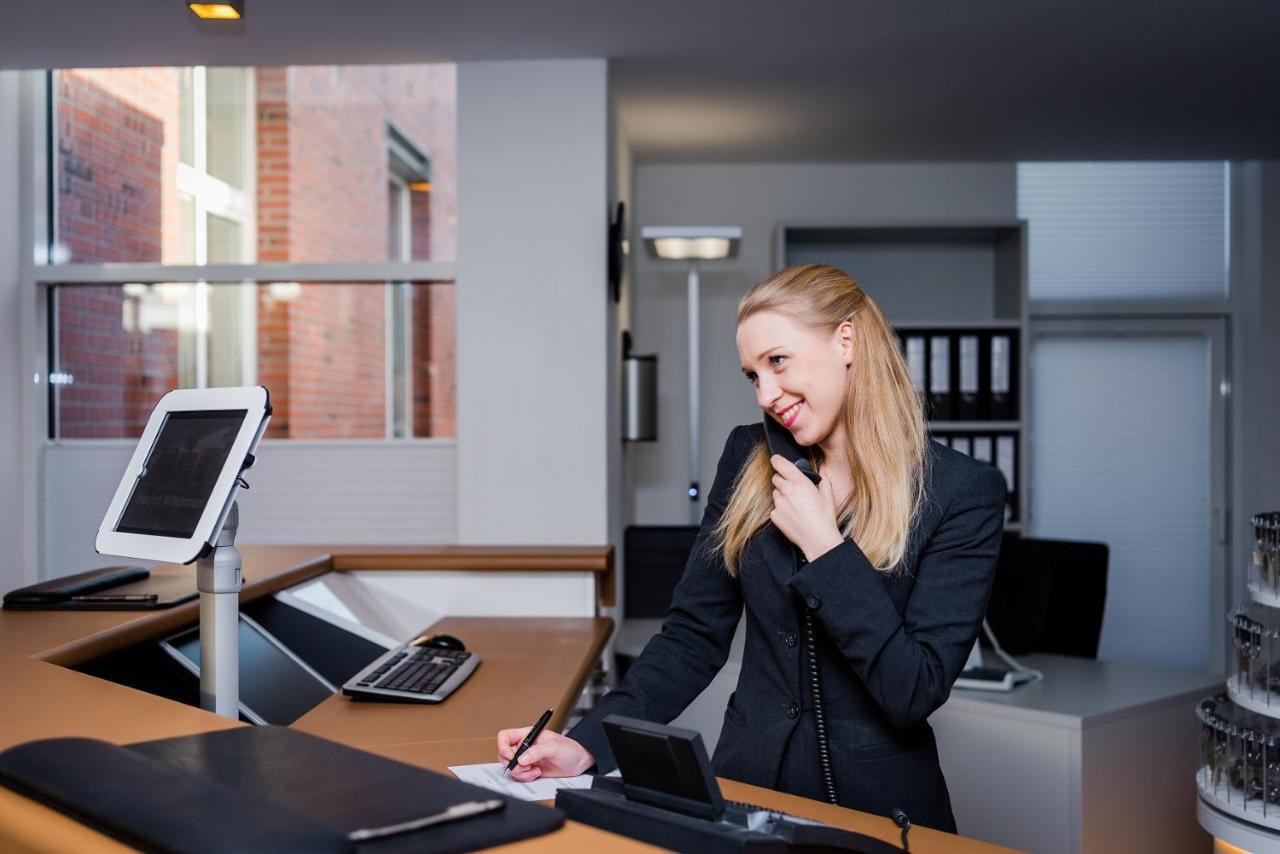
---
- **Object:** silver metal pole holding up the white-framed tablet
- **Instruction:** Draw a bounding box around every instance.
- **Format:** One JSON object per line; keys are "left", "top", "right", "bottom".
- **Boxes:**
{"left": 196, "top": 502, "right": 243, "bottom": 718}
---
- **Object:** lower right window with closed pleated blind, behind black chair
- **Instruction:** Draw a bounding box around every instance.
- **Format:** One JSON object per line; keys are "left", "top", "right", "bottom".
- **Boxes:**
{"left": 1030, "top": 319, "right": 1226, "bottom": 668}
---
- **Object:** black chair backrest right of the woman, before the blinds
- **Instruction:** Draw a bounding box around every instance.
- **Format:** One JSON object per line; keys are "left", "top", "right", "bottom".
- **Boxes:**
{"left": 987, "top": 534, "right": 1111, "bottom": 658}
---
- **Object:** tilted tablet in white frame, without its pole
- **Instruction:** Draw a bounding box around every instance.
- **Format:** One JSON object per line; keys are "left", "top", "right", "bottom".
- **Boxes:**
{"left": 96, "top": 385, "right": 271, "bottom": 563}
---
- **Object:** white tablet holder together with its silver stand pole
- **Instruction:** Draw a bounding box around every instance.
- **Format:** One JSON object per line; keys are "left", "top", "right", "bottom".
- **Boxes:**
{"left": 96, "top": 385, "right": 271, "bottom": 718}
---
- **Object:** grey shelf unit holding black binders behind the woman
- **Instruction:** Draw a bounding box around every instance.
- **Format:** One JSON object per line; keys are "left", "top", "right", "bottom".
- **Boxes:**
{"left": 773, "top": 219, "right": 1032, "bottom": 531}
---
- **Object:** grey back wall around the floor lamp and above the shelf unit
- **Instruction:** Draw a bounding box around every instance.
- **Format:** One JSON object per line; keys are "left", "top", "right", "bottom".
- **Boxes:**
{"left": 628, "top": 163, "right": 1016, "bottom": 525}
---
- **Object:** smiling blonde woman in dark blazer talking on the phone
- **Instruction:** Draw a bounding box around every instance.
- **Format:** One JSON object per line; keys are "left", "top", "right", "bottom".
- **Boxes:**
{"left": 498, "top": 265, "right": 1005, "bottom": 832}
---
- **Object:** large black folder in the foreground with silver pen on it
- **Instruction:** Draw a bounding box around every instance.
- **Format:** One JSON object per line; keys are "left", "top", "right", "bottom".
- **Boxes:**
{"left": 0, "top": 726, "right": 564, "bottom": 854}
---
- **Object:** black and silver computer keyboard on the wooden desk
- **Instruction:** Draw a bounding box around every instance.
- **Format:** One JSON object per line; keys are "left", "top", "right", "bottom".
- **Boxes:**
{"left": 342, "top": 644, "right": 480, "bottom": 703}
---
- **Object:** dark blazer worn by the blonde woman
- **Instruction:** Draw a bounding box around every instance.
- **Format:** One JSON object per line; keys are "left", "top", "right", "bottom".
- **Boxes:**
{"left": 570, "top": 424, "right": 1005, "bottom": 832}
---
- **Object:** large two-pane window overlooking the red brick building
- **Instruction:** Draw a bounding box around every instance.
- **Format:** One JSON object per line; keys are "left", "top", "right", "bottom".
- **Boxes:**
{"left": 41, "top": 65, "right": 456, "bottom": 438}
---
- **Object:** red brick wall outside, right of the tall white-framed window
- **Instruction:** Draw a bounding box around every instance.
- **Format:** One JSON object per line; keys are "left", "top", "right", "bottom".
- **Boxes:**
{"left": 250, "top": 67, "right": 456, "bottom": 438}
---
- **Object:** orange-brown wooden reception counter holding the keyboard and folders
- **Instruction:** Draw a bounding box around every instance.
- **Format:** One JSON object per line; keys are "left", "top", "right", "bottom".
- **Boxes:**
{"left": 0, "top": 545, "right": 1007, "bottom": 854}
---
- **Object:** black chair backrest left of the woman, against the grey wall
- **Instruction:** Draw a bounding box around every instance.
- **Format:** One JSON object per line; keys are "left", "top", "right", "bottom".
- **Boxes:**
{"left": 622, "top": 525, "right": 698, "bottom": 618}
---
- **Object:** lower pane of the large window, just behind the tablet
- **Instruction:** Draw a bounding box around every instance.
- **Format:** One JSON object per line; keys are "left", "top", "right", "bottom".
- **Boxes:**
{"left": 50, "top": 282, "right": 456, "bottom": 439}
